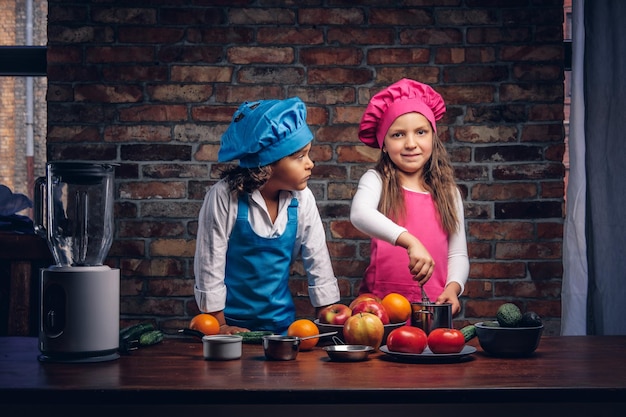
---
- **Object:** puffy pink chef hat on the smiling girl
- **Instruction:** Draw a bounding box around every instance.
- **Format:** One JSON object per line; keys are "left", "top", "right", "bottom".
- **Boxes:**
{"left": 359, "top": 78, "right": 446, "bottom": 148}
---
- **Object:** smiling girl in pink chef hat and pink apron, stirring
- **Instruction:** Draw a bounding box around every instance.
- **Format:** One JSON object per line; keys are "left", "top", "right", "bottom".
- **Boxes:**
{"left": 350, "top": 79, "right": 469, "bottom": 314}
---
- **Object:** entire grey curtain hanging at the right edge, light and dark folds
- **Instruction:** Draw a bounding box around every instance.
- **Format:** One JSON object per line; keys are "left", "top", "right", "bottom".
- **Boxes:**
{"left": 561, "top": 0, "right": 626, "bottom": 335}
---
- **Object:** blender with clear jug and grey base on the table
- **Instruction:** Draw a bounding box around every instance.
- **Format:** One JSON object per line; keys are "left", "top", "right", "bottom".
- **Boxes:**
{"left": 34, "top": 162, "right": 120, "bottom": 362}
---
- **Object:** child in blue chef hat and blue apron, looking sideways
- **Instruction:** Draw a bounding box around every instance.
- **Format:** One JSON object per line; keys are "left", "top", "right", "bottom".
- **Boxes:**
{"left": 194, "top": 98, "right": 339, "bottom": 334}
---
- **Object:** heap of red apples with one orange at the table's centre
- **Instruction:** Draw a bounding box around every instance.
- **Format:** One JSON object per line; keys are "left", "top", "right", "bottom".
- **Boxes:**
{"left": 318, "top": 293, "right": 411, "bottom": 349}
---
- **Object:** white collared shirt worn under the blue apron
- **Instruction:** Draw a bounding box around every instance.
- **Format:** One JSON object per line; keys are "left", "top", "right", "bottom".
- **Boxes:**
{"left": 194, "top": 180, "right": 339, "bottom": 312}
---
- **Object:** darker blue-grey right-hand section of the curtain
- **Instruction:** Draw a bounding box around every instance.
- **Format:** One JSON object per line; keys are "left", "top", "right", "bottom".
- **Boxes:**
{"left": 583, "top": 0, "right": 626, "bottom": 335}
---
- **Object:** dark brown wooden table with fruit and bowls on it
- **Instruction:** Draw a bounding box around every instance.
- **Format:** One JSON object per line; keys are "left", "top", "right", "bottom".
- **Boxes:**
{"left": 0, "top": 336, "right": 626, "bottom": 417}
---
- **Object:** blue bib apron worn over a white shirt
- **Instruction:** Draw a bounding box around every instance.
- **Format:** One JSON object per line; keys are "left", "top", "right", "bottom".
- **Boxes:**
{"left": 224, "top": 195, "right": 298, "bottom": 333}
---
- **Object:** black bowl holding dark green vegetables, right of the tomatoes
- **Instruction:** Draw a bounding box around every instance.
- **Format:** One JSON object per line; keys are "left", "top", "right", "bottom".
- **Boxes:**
{"left": 475, "top": 321, "right": 543, "bottom": 356}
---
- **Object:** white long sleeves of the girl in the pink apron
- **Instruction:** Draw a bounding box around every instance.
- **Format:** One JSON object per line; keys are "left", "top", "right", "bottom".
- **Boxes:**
{"left": 350, "top": 169, "right": 469, "bottom": 295}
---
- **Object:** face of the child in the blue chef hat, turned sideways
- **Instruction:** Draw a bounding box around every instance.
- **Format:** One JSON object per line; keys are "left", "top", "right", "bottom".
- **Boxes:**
{"left": 265, "top": 143, "right": 314, "bottom": 191}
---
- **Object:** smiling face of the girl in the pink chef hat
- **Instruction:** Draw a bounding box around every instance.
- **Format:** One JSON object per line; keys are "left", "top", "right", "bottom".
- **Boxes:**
{"left": 383, "top": 113, "right": 433, "bottom": 175}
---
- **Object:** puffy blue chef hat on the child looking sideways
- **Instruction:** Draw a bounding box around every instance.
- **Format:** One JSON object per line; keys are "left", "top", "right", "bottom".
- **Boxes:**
{"left": 217, "top": 97, "right": 313, "bottom": 168}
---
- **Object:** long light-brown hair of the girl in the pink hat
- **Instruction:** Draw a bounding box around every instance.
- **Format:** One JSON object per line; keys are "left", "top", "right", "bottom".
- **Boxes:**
{"left": 375, "top": 133, "right": 459, "bottom": 235}
